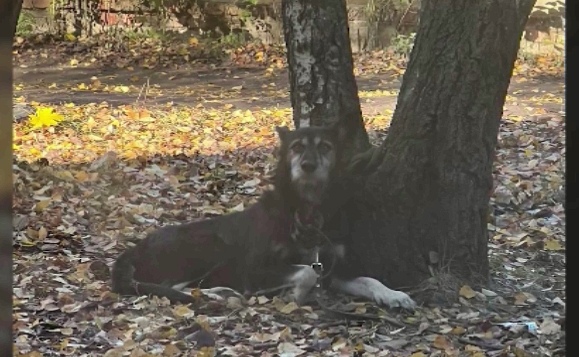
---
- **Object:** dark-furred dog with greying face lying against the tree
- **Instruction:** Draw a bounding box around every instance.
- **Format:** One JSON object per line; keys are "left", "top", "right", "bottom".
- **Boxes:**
{"left": 112, "top": 127, "right": 415, "bottom": 309}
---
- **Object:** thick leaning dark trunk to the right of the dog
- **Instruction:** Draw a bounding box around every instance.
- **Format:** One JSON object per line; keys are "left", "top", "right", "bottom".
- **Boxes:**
{"left": 350, "top": 0, "right": 535, "bottom": 294}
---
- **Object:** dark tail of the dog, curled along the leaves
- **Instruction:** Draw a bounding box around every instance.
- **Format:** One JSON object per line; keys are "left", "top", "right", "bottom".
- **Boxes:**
{"left": 111, "top": 248, "right": 195, "bottom": 304}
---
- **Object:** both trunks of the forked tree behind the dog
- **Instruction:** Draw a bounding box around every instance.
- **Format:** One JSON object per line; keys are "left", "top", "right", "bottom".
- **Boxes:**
{"left": 282, "top": 0, "right": 535, "bottom": 300}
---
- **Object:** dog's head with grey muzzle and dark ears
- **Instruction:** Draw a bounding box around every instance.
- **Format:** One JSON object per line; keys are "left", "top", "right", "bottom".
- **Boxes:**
{"left": 276, "top": 126, "right": 341, "bottom": 206}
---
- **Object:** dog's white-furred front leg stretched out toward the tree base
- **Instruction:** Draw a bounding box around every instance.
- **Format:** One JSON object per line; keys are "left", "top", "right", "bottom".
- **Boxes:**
{"left": 330, "top": 277, "right": 416, "bottom": 310}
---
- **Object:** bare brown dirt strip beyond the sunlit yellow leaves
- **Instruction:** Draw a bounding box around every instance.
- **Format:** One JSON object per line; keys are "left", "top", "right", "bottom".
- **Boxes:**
{"left": 14, "top": 58, "right": 564, "bottom": 116}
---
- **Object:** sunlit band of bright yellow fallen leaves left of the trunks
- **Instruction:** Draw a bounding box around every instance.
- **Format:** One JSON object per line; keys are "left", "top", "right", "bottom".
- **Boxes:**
{"left": 14, "top": 104, "right": 290, "bottom": 163}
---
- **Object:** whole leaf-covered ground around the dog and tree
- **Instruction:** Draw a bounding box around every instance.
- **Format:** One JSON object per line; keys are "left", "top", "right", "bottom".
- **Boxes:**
{"left": 13, "top": 39, "right": 566, "bottom": 357}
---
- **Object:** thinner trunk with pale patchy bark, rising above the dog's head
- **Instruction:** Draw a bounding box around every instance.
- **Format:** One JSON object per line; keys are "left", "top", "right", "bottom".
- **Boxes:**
{"left": 282, "top": 0, "right": 370, "bottom": 154}
